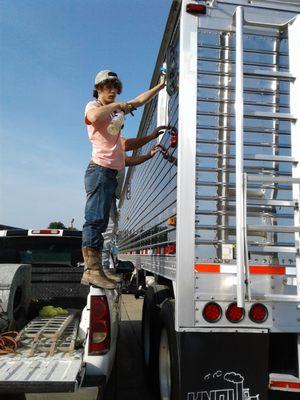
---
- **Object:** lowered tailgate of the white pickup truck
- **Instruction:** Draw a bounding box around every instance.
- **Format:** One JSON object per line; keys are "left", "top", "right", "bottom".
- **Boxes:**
{"left": 0, "top": 357, "right": 82, "bottom": 393}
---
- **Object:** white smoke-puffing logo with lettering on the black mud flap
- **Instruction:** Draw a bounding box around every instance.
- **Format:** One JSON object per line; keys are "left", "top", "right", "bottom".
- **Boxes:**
{"left": 187, "top": 370, "right": 260, "bottom": 400}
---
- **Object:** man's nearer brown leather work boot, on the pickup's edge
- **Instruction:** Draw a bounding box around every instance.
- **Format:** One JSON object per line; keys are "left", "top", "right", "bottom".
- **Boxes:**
{"left": 81, "top": 247, "right": 116, "bottom": 289}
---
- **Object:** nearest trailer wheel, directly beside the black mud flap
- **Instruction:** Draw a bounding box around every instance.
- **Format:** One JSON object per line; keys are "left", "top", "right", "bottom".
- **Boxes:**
{"left": 159, "top": 300, "right": 180, "bottom": 400}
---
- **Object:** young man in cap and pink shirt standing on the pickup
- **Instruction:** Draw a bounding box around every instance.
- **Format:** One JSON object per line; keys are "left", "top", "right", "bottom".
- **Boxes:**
{"left": 81, "top": 70, "right": 165, "bottom": 289}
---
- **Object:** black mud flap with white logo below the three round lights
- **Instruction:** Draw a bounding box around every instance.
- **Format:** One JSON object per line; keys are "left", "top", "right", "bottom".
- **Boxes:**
{"left": 179, "top": 333, "right": 269, "bottom": 400}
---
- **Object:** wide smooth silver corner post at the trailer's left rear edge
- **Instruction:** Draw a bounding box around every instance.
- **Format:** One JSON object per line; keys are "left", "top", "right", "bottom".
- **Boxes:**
{"left": 175, "top": 0, "right": 198, "bottom": 331}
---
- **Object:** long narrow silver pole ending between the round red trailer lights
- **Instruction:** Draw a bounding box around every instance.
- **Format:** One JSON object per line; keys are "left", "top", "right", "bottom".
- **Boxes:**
{"left": 235, "top": 6, "right": 245, "bottom": 307}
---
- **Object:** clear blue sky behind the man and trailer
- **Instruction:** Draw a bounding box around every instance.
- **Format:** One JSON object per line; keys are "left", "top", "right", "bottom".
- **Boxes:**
{"left": 0, "top": 0, "right": 172, "bottom": 229}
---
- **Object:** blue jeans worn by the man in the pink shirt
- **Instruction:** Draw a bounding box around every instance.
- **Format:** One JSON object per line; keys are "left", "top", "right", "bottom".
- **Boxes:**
{"left": 82, "top": 163, "right": 118, "bottom": 251}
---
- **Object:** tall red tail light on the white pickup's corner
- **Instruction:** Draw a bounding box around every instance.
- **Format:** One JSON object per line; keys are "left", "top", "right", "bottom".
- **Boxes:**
{"left": 89, "top": 296, "right": 110, "bottom": 355}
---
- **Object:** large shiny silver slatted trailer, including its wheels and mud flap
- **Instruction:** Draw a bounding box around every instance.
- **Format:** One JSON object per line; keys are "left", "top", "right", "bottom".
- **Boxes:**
{"left": 119, "top": 0, "right": 300, "bottom": 400}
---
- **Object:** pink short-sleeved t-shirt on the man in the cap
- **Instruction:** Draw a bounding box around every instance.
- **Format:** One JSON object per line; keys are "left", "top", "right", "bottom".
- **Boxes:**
{"left": 85, "top": 100, "right": 125, "bottom": 170}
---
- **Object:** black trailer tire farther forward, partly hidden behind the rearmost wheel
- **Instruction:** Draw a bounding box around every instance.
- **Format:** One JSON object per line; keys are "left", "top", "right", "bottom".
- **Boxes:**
{"left": 142, "top": 285, "right": 170, "bottom": 391}
